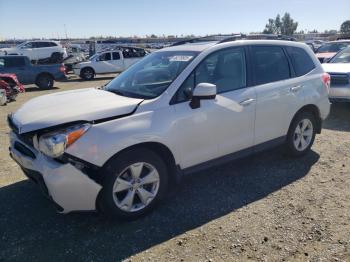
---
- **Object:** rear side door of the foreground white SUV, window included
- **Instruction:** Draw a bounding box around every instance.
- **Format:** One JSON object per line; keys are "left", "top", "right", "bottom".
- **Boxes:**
{"left": 250, "top": 45, "right": 304, "bottom": 145}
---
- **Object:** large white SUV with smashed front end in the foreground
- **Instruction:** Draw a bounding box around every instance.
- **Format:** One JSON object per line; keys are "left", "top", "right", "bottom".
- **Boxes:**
{"left": 8, "top": 40, "right": 330, "bottom": 218}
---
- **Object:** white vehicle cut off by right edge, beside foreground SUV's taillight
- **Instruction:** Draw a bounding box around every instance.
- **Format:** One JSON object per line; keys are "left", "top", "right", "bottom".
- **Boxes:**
{"left": 322, "top": 46, "right": 350, "bottom": 102}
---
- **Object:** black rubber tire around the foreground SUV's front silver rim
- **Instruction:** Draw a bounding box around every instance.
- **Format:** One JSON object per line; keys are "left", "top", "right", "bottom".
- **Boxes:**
{"left": 97, "top": 148, "right": 168, "bottom": 220}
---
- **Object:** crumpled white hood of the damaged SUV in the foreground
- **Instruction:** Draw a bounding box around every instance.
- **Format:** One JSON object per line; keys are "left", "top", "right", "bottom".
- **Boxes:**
{"left": 12, "top": 88, "right": 143, "bottom": 133}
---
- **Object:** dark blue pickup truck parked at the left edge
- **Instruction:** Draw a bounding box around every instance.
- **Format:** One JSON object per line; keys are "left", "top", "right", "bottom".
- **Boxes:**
{"left": 0, "top": 55, "right": 66, "bottom": 88}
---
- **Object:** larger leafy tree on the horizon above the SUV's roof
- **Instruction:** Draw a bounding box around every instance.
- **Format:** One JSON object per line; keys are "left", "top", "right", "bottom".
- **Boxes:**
{"left": 263, "top": 13, "right": 298, "bottom": 35}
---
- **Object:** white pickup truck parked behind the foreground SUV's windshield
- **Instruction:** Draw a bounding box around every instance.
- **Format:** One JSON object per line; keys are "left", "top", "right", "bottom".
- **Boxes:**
{"left": 73, "top": 49, "right": 147, "bottom": 80}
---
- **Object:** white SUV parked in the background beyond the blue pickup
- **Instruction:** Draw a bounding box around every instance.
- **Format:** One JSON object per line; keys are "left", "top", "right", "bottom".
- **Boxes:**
{"left": 0, "top": 40, "right": 67, "bottom": 61}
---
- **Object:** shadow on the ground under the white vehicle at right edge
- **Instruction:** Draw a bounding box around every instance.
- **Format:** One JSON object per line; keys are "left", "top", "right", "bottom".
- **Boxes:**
{"left": 323, "top": 103, "right": 350, "bottom": 132}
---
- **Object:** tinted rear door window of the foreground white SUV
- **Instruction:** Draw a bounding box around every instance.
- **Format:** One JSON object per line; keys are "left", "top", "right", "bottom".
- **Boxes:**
{"left": 251, "top": 46, "right": 291, "bottom": 85}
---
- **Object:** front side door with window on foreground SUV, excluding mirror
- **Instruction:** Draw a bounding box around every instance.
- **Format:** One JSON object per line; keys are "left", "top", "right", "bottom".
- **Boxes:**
{"left": 174, "top": 48, "right": 256, "bottom": 168}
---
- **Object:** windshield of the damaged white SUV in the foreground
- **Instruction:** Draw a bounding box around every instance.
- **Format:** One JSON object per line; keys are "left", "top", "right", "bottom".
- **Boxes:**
{"left": 104, "top": 51, "right": 198, "bottom": 99}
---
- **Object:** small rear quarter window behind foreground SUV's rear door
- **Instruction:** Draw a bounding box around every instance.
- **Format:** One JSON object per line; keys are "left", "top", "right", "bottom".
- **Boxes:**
{"left": 287, "top": 46, "right": 315, "bottom": 76}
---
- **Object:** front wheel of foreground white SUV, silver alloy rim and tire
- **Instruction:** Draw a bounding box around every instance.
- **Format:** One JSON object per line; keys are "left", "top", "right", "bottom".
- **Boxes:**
{"left": 98, "top": 149, "right": 168, "bottom": 219}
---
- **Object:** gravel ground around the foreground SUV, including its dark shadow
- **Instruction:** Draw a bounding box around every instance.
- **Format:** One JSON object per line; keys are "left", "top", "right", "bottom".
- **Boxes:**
{"left": 0, "top": 74, "right": 350, "bottom": 261}
